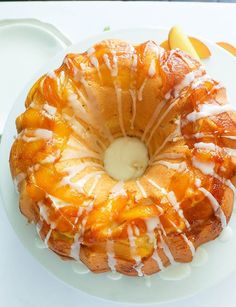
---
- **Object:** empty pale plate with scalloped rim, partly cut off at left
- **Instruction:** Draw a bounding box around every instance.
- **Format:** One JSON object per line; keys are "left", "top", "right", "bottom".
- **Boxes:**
{"left": 0, "top": 19, "right": 71, "bottom": 135}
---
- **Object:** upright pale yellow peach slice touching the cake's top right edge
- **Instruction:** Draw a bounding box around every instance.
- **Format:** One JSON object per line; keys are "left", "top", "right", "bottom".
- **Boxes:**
{"left": 168, "top": 26, "right": 200, "bottom": 60}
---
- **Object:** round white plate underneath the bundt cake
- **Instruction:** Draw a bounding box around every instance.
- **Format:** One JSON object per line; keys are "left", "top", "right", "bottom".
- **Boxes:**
{"left": 0, "top": 29, "right": 236, "bottom": 304}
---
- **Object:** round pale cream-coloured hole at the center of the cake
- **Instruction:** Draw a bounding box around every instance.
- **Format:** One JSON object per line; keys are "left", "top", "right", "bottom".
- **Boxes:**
{"left": 104, "top": 137, "right": 149, "bottom": 180}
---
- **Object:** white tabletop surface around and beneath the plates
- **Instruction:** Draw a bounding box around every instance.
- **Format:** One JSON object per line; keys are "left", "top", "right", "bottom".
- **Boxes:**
{"left": 0, "top": 1, "right": 236, "bottom": 307}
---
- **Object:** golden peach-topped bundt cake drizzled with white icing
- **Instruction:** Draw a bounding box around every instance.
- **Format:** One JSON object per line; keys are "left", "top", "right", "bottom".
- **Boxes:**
{"left": 10, "top": 40, "right": 236, "bottom": 276}
